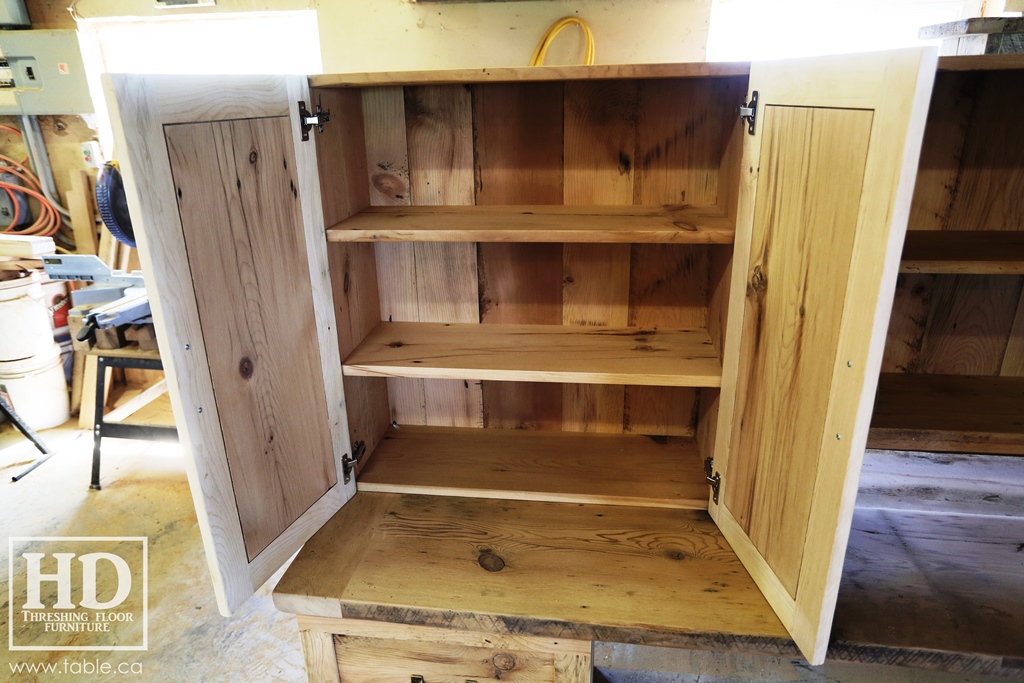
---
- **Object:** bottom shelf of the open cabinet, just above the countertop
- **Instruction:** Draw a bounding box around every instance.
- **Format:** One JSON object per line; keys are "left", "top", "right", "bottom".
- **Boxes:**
{"left": 356, "top": 425, "right": 709, "bottom": 510}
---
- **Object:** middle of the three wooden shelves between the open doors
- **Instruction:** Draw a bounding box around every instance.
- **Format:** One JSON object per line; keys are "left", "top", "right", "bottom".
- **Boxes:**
{"left": 343, "top": 323, "right": 722, "bottom": 387}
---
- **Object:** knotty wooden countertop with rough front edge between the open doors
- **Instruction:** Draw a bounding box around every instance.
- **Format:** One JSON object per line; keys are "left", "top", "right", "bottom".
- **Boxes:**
{"left": 274, "top": 492, "right": 795, "bottom": 654}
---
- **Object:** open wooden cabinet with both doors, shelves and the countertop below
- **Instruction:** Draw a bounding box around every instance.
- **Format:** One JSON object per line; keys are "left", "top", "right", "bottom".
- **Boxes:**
{"left": 108, "top": 50, "right": 1019, "bottom": 680}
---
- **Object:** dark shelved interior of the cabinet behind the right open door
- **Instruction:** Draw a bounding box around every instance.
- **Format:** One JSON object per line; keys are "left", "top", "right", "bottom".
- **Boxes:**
{"left": 868, "top": 70, "right": 1024, "bottom": 455}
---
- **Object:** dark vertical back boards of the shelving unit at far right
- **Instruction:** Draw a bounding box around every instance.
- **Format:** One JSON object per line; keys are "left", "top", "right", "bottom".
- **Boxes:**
{"left": 882, "top": 72, "right": 1024, "bottom": 377}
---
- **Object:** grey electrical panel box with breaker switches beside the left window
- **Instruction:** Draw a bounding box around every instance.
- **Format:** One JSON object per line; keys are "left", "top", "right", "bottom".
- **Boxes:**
{"left": 0, "top": 30, "right": 94, "bottom": 116}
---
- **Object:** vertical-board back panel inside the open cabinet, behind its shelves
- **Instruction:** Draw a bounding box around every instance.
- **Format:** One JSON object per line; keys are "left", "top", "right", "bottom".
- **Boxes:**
{"left": 362, "top": 78, "right": 745, "bottom": 435}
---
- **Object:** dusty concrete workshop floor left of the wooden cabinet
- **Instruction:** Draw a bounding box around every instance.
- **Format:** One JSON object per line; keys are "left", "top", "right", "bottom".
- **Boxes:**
{"left": 0, "top": 397, "right": 306, "bottom": 683}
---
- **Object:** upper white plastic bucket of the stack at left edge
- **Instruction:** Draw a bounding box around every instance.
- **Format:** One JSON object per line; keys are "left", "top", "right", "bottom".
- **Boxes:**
{"left": 0, "top": 272, "right": 53, "bottom": 362}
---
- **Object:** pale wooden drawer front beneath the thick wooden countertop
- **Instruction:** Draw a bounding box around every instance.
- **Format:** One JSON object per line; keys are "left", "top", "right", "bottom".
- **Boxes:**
{"left": 299, "top": 617, "right": 591, "bottom": 683}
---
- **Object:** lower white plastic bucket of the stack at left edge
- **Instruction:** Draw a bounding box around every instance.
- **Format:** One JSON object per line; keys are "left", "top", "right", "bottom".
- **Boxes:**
{"left": 0, "top": 344, "right": 71, "bottom": 429}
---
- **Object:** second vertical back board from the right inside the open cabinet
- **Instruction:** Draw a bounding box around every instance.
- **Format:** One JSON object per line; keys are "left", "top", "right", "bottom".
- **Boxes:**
{"left": 562, "top": 81, "right": 637, "bottom": 433}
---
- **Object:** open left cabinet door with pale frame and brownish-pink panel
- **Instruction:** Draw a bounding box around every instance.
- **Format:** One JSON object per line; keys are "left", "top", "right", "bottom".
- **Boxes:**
{"left": 104, "top": 75, "right": 355, "bottom": 614}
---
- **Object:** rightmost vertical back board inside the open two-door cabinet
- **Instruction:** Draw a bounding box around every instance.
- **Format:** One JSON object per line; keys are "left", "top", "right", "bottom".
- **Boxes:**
{"left": 625, "top": 78, "right": 746, "bottom": 435}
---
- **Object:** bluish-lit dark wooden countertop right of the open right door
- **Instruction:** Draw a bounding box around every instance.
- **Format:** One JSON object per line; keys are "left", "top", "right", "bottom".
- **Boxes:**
{"left": 829, "top": 453, "right": 1024, "bottom": 667}
